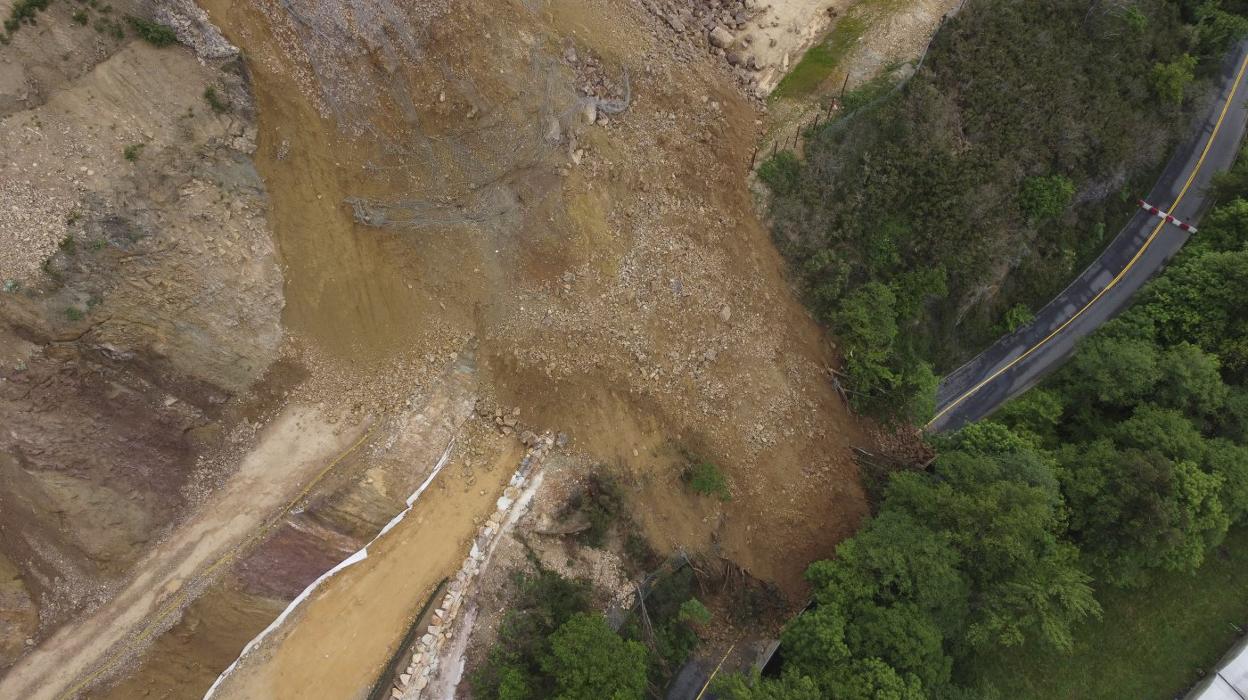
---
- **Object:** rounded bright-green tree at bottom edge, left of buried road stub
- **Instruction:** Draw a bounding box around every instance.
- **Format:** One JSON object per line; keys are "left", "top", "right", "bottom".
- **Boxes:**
{"left": 542, "top": 613, "right": 645, "bottom": 700}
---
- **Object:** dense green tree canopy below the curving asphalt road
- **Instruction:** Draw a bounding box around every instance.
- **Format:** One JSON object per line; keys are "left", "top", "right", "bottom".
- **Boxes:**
{"left": 724, "top": 154, "right": 1248, "bottom": 700}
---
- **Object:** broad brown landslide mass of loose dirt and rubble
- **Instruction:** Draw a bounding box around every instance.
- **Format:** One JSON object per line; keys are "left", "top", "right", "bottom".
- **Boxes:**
{"left": 199, "top": 0, "right": 862, "bottom": 590}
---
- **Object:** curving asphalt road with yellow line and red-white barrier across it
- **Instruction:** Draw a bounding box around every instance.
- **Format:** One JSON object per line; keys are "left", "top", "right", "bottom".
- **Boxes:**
{"left": 926, "top": 40, "right": 1248, "bottom": 432}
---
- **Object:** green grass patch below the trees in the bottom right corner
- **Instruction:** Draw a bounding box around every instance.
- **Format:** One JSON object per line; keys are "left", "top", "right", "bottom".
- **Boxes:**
{"left": 965, "top": 528, "right": 1248, "bottom": 700}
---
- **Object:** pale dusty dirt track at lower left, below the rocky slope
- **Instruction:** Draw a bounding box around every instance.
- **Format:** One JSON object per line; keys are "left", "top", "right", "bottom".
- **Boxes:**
{"left": 0, "top": 406, "right": 368, "bottom": 700}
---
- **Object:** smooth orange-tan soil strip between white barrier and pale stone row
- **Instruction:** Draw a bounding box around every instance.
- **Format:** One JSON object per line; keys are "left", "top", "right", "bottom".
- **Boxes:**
{"left": 203, "top": 423, "right": 523, "bottom": 700}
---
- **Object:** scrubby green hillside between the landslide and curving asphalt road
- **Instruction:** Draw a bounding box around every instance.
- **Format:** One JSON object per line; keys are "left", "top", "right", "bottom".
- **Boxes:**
{"left": 760, "top": 0, "right": 1244, "bottom": 418}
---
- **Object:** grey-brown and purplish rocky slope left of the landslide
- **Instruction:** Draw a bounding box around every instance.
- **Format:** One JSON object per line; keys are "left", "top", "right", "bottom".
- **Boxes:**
{"left": 0, "top": 8, "right": 282, "bottom": 668}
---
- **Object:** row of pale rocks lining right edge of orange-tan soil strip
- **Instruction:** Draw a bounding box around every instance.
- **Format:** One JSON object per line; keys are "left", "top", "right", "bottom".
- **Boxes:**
{"left": 391, "top": 433, "right": 557, "bottom": 700}
